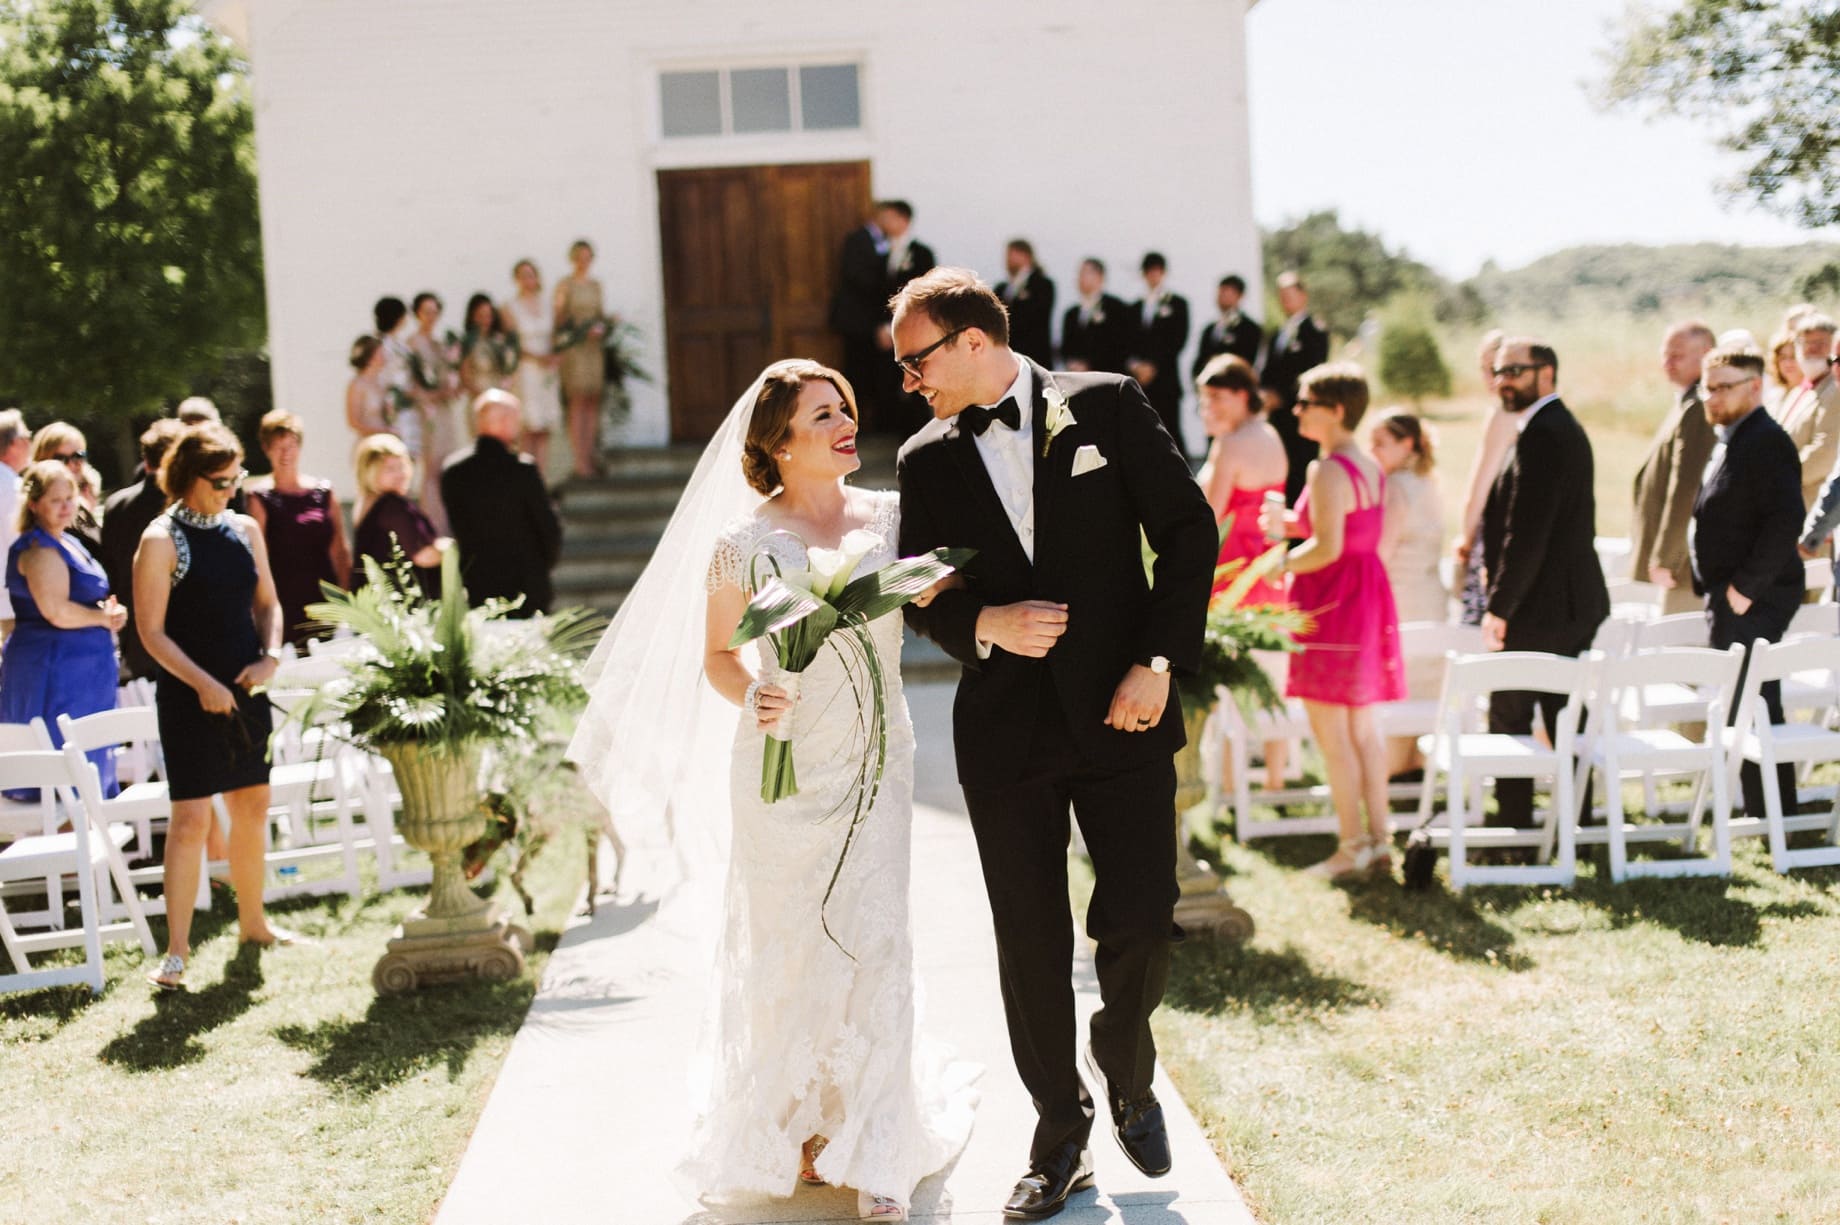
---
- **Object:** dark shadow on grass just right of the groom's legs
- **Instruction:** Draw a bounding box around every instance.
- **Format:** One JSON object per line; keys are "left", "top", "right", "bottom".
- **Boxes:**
{"left": 1163, "top": 944, "right": 1384, "bottom": 1021}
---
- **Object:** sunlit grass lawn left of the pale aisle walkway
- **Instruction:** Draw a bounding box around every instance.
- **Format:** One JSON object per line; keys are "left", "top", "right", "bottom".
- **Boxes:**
{"left": 0, "top": 839, "right": 583, "bottom": 1225}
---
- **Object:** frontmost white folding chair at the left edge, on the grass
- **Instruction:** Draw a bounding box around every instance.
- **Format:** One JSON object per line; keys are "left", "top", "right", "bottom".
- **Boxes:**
{"left": 0, "top": 750, "right": 156, "bottom": 995}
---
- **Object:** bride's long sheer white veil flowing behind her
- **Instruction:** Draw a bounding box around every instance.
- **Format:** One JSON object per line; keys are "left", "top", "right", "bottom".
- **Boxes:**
{"left": 569, "top": 362, "right": 788, "bottom": 877}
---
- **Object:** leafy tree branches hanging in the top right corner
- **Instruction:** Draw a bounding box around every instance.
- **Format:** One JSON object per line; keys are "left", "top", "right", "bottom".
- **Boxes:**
{"left": 1603, "top": 0, "right": 1840, "bottom": 228}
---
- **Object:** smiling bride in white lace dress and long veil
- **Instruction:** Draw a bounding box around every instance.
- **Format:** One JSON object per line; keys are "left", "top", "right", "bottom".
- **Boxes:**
{"left": 569, "top": 359, "right": 975, "bottom": 1221}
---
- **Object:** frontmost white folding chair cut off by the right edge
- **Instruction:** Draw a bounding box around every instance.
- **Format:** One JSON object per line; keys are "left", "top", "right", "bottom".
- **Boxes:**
{"left": 1726, "top": 638, "right": 1840, "bottom": 872}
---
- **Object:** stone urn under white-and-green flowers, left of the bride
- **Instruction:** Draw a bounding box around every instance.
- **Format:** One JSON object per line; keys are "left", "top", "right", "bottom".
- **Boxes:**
{"left": 370, "top": 743, "right": 530, "bottom": 995}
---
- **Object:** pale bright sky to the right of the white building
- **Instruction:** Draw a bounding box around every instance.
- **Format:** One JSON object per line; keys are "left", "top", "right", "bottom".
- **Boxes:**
{"left": 1248, "top": 0, "right": 1840, "bottom": 276}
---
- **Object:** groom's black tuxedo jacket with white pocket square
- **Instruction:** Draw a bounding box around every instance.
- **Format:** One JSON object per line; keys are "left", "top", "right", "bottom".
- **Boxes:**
{"left": 896, "top": 359, "right": 1216, "bottom": 785}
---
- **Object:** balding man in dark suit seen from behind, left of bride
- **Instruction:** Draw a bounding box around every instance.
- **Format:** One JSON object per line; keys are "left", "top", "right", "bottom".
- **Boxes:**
{"left": 442, "top": 390, "right": 563, "bottom": 616}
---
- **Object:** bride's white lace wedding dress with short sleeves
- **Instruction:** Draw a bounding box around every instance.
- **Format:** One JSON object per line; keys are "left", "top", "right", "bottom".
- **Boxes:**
{"left": 679, "top": 493, "right": 977, "bottom": 1205}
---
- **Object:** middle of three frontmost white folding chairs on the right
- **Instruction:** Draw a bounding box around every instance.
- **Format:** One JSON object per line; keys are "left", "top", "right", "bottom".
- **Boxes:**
{"left": 1575, "top": 646, "right": 1744, "bottom": 881}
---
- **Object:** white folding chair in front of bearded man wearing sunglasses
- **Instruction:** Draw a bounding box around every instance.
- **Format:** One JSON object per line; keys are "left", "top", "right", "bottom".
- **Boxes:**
{"left": 1419, "top": 651, "right": 1601, "bottom": 890}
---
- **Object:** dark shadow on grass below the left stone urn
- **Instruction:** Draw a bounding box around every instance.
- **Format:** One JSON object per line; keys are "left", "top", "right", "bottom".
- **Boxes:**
{"left": 274, "top": 971, "right": 537, "bottom": 1094}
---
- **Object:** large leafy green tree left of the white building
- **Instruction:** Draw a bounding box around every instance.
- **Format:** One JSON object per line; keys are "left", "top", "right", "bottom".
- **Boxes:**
{"left": 0, "top": 0, "right": 265, "bottom": 419}
